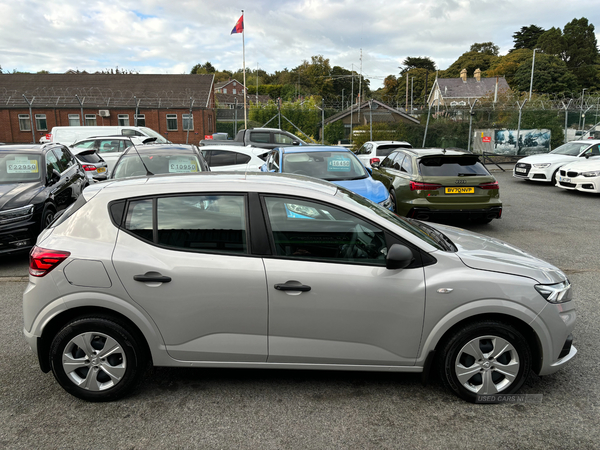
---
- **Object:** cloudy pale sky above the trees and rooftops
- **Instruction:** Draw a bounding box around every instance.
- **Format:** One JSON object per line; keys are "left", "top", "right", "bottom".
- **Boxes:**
{"left": 0, "top": 0, "right": 600, "bottom": 89}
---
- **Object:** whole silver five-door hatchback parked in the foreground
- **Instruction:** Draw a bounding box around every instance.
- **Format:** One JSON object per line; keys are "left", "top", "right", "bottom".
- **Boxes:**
{"left": 23, "top": 172, "right": 577, "bottom": 403}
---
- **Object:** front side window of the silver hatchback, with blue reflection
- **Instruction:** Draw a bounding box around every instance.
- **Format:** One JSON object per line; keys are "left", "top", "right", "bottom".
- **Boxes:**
{"left": 265, "top": 197, "right": 387, "bottom": 266}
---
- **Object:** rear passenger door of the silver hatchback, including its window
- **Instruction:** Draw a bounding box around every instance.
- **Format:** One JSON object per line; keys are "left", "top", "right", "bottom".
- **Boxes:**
{"left": 113, "top": 193, "right": 267, "bottom": 362}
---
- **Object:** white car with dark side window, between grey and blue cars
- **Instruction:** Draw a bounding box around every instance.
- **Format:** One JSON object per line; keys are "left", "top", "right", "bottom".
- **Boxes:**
{"left": 201, "top": 145, "right": 271, "bottom": 172}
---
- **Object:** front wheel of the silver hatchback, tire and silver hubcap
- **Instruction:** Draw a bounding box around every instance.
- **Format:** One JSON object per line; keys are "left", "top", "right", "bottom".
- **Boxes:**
{"left": 439, "top": 320, "right": 532, "bottom": 403}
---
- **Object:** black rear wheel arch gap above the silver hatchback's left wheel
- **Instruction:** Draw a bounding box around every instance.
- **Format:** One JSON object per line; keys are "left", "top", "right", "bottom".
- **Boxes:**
{"left": 37, "top": 306, "right": 152, "bottom": 373}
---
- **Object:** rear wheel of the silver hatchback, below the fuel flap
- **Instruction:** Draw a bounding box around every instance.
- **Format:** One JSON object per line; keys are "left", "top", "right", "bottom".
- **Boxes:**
{"left": 50, "top": 316, "right": 146, "bottom": 402}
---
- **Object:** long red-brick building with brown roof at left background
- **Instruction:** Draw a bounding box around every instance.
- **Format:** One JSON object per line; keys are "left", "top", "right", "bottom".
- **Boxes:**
{"left": 0, "top": 73, "right": 216, "bottom": 143}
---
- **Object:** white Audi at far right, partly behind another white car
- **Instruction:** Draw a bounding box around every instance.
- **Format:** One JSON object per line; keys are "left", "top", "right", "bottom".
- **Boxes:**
{"left": 513, "top": 139, "right": 600, "bottom": 184}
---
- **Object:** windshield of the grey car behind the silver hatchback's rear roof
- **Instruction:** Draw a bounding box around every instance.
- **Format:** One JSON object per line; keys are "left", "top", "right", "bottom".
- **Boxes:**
{"left": 112, "top": 151, "right": 202, "bottom": 179}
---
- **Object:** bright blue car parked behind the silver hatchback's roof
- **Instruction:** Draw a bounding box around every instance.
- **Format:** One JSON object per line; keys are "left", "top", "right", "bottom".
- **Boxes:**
{"left": 260, "top": 145, "right": 393, "bottom": 210}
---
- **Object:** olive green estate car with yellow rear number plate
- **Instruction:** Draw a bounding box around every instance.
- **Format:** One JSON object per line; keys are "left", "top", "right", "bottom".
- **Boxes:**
{"left": 372, "top": 148, "right": 502, "bottom": 223}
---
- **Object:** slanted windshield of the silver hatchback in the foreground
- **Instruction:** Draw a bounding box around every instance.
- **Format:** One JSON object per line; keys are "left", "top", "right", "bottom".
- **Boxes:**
{"left": 336, "top": 188, "right": 453, "bottom": 250}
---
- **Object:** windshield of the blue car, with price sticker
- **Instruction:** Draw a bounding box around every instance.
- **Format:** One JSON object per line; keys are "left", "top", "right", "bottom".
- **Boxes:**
{"left": 282, "top": 151, "right": 368, "bottom": 181}
